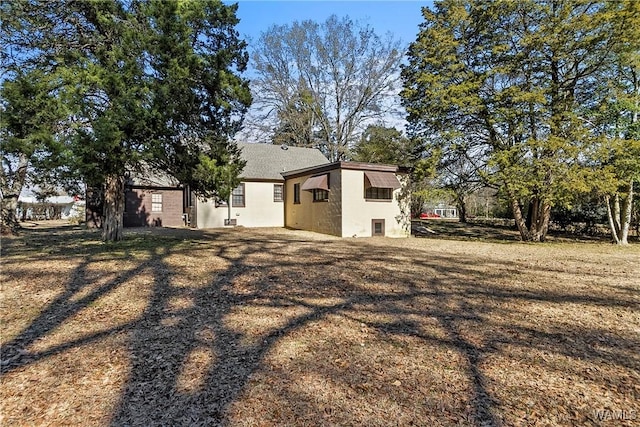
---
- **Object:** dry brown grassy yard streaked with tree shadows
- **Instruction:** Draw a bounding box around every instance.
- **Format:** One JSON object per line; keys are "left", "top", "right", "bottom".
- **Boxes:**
{"left": 0, "top": 222, "right": 640, "bottom": 426}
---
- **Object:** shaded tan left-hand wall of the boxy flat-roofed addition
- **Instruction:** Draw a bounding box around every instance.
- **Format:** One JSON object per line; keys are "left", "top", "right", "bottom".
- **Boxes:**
{"left": 285, "top": 169, "right": 342, "bottom": 236}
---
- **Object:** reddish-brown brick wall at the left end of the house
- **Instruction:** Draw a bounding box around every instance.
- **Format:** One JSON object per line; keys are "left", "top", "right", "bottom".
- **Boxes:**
{"left": 124, "top": 188, "right": 184, "bottom": 227}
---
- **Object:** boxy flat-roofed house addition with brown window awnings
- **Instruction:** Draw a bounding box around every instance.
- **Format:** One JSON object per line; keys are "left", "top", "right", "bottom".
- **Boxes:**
{"left": 282, "top": 162, "right": 407, "bottom": 237}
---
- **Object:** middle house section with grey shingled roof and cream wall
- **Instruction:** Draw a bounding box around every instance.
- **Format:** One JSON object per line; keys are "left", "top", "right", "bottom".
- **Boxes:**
{"left": 190, "top": 143, "right": 328, "bottom": 228}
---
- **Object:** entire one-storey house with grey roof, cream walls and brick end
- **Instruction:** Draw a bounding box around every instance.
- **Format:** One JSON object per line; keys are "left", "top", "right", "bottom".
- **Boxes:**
{"left": 119, "top": 143, "right": 407, "bottom": 237}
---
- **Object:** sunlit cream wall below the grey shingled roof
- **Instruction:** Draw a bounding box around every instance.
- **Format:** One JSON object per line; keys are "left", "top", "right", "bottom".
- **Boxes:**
{"left": 196, "top": 182, "right": 284, "bottom": 228}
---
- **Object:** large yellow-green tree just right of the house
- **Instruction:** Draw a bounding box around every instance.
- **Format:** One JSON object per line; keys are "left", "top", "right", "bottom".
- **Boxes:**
{"left": 401, "top": 0, "right": 638, "bottom": 241}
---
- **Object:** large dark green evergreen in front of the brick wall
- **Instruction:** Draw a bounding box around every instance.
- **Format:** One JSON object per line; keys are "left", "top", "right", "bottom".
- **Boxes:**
{"left": 2, "top": 0, "right": 251, "bottom": 240}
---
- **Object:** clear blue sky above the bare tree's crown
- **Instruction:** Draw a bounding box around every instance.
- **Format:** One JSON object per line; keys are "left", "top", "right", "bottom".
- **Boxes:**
{"left": 225, "top": 0, "right": 432, "bottom": 45}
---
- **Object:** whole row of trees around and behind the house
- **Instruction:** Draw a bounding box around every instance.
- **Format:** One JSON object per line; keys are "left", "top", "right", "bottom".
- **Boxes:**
{"left": 0, "top": 0, "right": 640, "bottom": 244}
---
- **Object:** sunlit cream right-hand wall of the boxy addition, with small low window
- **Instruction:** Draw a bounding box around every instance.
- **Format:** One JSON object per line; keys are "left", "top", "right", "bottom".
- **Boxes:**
{"left": 342, "top": 169, "right": 407, "bottom": 237}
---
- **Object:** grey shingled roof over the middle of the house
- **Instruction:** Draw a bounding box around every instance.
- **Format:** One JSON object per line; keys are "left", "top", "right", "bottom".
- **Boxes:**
{"left": 238, "top": 143, "right": 329, "bottom": 181}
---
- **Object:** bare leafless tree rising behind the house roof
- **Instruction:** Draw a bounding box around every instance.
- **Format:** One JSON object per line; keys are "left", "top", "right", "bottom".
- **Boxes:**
{"left": 252, "top": 15, "right": 402, "bottom": 161}
